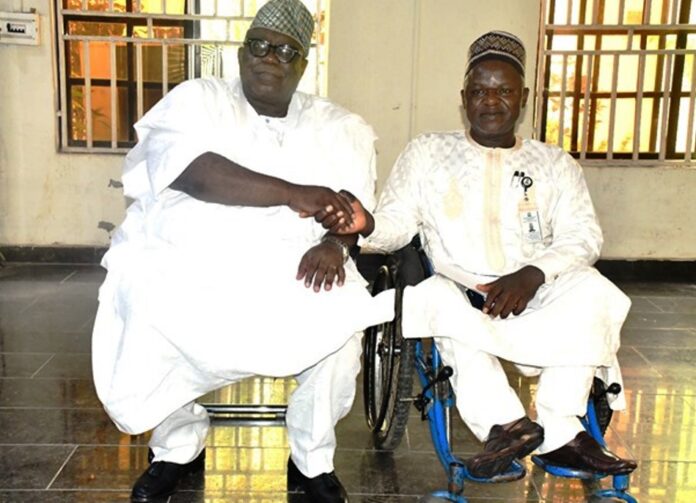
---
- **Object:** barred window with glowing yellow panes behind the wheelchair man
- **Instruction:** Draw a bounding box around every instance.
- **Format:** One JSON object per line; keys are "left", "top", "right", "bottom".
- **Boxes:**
{"left": 536, "top": 0, "right": 696, "bottom": 165}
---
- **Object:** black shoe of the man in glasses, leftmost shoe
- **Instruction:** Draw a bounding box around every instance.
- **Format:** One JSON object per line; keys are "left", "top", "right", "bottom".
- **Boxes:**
{"left": 131, "top": 449, "right": 205, "bottom": 503}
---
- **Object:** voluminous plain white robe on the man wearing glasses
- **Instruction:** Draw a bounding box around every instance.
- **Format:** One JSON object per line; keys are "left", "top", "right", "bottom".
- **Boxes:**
{"left": 93, "top": 79, "right": 393, "bottom": 433}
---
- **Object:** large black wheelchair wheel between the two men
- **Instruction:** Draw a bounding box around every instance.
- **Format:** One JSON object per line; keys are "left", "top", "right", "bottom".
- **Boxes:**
{"left": 363, "top": 266, "right": 415, "bottom": 450}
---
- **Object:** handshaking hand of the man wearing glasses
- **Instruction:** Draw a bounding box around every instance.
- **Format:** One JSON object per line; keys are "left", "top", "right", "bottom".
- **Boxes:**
{"left": 288, "top": 185, "right": 353, "bottom": 228}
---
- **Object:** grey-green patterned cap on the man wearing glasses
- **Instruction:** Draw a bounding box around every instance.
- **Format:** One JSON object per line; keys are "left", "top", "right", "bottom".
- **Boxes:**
{"left": 249, "top": 0, "right": 314, "bottom": 56}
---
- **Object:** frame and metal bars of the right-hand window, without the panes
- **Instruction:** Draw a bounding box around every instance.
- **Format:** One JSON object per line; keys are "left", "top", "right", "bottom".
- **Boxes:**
{"left": 534, "top": 0, "right": 696, "bottom": 165}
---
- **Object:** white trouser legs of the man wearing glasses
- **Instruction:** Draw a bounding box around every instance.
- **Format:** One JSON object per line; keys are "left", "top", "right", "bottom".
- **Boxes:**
{"left": 149, "top": 334, "right": 362, "bottom": 477}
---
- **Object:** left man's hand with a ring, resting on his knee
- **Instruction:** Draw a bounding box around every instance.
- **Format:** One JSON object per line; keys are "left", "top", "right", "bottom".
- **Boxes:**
{"left": 296, "top": 242, "right": 346, "bottom": 292}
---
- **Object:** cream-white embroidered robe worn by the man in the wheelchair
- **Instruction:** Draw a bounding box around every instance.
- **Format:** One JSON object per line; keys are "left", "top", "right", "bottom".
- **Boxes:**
{"left": 362, "top": 131, "right": 630, "bottom": 408}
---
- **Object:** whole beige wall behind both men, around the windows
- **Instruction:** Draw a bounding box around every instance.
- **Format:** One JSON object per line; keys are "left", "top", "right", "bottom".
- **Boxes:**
{"left": 0, "top": 0, "right": 696, "bottom": 260}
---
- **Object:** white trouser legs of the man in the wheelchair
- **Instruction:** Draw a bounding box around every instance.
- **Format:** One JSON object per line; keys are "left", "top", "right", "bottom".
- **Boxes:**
{"left": 435, "top": 337, "right": 595, "bottom": 454}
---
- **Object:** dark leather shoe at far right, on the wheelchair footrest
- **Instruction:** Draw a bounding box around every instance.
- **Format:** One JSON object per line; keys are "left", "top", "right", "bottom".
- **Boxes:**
{"left": 539, "top": 431, "right": 638, "bottom": 475}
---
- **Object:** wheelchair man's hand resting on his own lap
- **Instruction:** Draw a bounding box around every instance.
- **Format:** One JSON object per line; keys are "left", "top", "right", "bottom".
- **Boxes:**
{"left": 476, "top": 265, "right": 544, "bottom": 319}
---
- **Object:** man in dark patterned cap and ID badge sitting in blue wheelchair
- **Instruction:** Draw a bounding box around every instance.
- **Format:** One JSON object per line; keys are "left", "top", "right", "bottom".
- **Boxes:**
{"left": 340, "top": 32, "right": 636, "bottom": 478}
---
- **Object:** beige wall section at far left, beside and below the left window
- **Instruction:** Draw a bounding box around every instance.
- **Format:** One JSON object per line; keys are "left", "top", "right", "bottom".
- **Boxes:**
{"left": 0, "top": 0, "right": 124, "bottom": 245}
